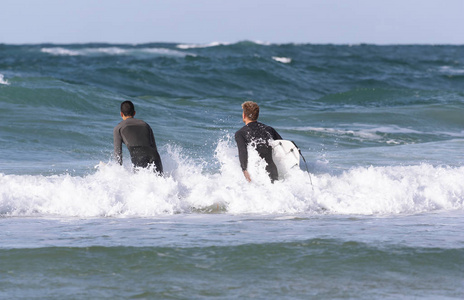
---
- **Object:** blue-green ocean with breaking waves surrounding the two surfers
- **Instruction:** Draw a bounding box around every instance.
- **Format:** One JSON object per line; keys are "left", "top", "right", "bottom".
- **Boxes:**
{"left": 0, "top": 41, "right": 464, "bottom": 299}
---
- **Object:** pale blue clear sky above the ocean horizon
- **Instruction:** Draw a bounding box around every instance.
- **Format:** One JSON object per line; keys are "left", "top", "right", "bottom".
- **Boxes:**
{"left": 0, "top": 0, "right": 464, "bottom": 45}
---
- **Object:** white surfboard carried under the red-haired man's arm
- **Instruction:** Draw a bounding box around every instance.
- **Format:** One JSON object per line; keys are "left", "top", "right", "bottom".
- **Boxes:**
{"left": 270, "top": 140, "right": 300, "bottom": 178}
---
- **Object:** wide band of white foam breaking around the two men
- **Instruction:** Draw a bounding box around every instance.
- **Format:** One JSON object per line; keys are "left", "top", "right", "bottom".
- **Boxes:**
{"left": 0, "top": 140, "right": 464, "bottom": 217}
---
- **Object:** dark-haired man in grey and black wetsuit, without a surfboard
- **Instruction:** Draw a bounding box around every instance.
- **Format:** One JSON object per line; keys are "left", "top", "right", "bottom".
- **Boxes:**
{"left": 113, "top": 101, "right": 163, "bottom": 174}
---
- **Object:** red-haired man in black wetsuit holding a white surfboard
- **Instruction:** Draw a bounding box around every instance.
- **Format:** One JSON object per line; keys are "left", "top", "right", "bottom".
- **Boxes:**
{"left": 235, "top": 101, "right": 282, "bottom": 182}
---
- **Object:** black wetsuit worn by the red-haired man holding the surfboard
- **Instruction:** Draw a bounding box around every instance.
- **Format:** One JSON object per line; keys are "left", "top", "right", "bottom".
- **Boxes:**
{"left": 235, "top": 122, "right": 282, "bottom": 181}
